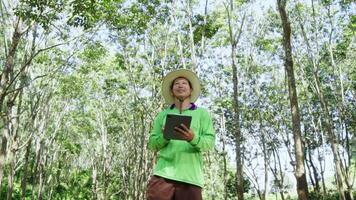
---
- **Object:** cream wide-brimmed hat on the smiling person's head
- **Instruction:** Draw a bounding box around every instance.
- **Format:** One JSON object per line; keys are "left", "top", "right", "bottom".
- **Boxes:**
{"left": 162, "top": 69, "right": 201, "bottom": 104}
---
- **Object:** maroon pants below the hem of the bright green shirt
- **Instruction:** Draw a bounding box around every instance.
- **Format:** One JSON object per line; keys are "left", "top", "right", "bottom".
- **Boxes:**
{"left": 147, "top": 176, "right": 203, "bottom": 200}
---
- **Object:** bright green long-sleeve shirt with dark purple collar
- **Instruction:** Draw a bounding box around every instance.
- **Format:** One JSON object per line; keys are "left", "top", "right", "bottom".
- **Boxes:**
{"left": 148, "top": 108, "right": 215, "bottom": 187}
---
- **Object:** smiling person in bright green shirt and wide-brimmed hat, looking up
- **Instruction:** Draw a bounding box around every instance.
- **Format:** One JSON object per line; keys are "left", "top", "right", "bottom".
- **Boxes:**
{"left": 146, "top": 69, "right": 215, "bottom": 200}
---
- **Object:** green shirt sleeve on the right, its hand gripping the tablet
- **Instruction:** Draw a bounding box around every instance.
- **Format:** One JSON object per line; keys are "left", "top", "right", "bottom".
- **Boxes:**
{"left": 190, "top": 110, "right": 215, "bottom": 151}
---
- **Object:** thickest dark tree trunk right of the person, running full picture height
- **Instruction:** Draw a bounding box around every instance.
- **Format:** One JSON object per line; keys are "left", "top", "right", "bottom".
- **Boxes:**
{"left": 277, "top": 0, "right": 308, "bottom": 200}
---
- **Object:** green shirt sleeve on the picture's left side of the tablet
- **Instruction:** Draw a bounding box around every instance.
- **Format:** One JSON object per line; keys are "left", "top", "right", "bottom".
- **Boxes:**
{"left": 148, "top": 112, "right": 169, "bottom": 151}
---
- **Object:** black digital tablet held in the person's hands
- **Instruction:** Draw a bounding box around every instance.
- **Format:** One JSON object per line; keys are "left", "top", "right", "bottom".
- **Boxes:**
{"left": 163, "top": 114, "right": 192, "bottom": 140}
